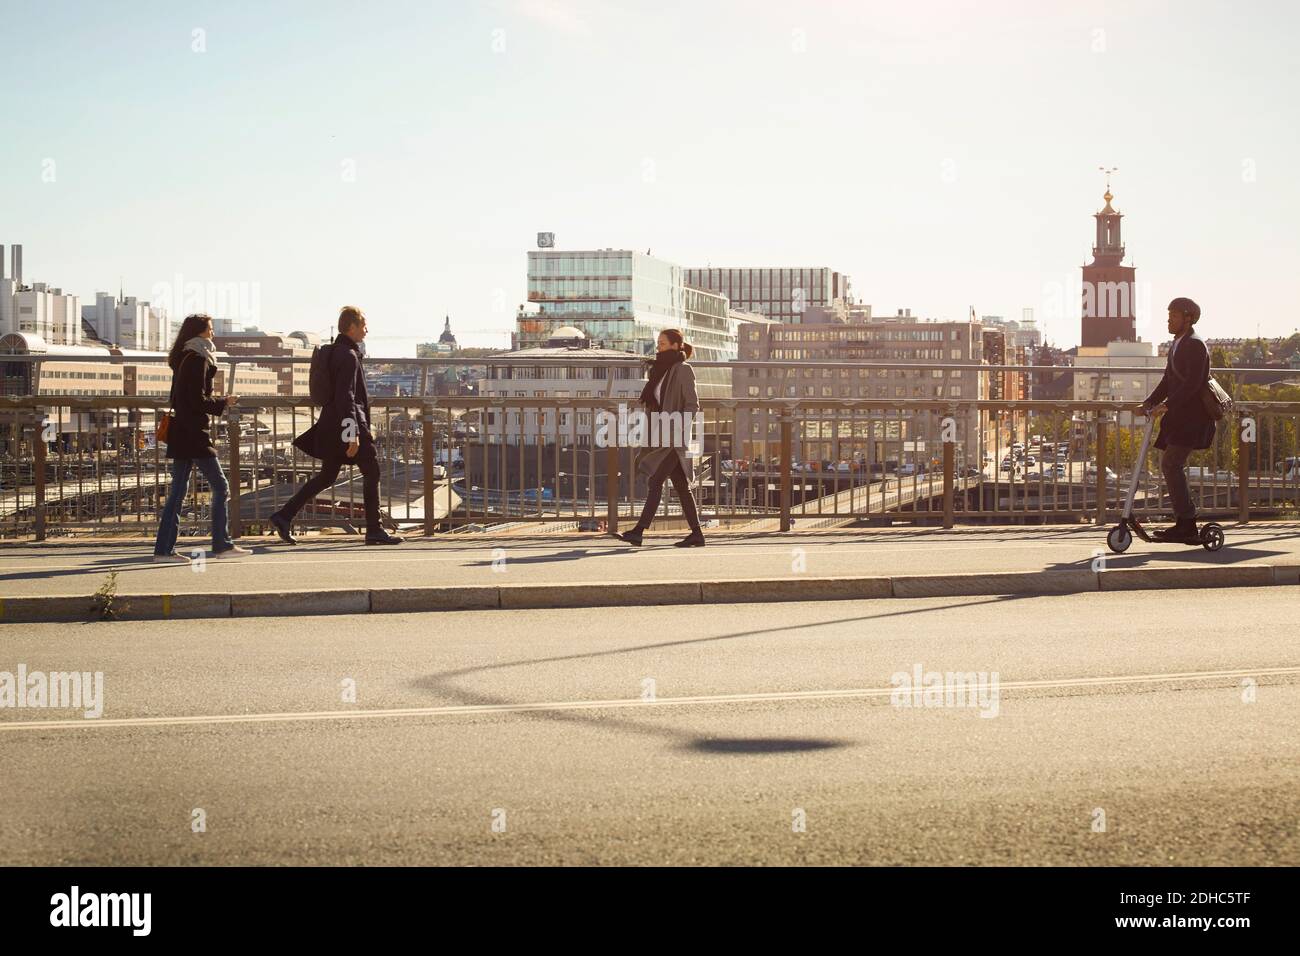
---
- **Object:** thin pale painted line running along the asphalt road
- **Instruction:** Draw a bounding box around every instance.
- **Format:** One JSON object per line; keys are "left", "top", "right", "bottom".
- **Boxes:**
{"left": 0, "top": 667, "right": 1300, "bottom": 732}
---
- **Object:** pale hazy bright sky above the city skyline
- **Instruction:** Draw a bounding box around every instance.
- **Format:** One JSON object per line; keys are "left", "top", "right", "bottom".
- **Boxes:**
{"left": 0, "top": 0, "right": 1300, "bottom": 356}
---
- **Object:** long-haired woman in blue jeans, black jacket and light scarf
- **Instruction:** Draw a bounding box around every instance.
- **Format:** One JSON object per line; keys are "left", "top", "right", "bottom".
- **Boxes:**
{"left": 153, "top": 315, "right": 252, "bottom": 564}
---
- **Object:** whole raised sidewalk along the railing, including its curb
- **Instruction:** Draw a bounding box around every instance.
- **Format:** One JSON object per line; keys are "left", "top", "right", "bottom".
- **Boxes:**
{"left": 0, "top": 522, "right": 1300, "bottom": 622}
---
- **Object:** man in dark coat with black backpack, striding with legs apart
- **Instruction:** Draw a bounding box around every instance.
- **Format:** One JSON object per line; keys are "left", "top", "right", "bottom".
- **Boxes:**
{"left": 270, "top": 306, "right": 402, "bottom": 545}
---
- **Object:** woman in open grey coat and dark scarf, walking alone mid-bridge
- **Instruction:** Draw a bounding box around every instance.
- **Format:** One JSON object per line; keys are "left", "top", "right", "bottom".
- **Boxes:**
{"left": 619, "top": 329, "right": 705, "bottom": 548}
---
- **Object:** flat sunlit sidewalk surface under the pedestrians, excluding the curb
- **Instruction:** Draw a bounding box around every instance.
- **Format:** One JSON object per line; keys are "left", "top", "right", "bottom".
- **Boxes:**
{"left": 0, "top": 522, "right": 1300, "bottom": 597}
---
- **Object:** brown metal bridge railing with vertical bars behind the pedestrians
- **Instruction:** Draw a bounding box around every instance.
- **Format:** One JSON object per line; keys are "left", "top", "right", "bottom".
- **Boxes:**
{"left": 0, "top": 395, "right": 1300, "bottom": 538}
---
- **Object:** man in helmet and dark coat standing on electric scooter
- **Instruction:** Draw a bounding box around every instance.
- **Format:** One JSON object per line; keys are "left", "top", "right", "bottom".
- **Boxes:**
{"left": 1139, "top": 298, "right": 1214, "bottom": 545}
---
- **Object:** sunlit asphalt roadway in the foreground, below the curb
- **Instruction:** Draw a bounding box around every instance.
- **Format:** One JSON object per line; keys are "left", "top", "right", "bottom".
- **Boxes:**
{"left": 0, "top": 588, "right": 1300, "bottom": 865}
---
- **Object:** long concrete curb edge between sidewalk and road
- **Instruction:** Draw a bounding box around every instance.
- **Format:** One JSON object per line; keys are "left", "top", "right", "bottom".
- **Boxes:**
{"left": 0, "top": 564, "right": 1300, "bottom": 624}
